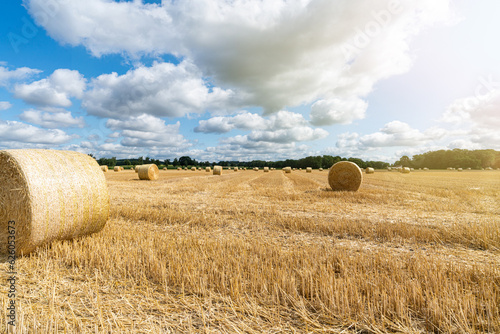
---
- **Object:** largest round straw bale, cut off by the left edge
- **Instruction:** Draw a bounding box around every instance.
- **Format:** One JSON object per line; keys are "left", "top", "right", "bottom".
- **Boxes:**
{"left": 0, "top": 150, "right": 109, "bottom": 255}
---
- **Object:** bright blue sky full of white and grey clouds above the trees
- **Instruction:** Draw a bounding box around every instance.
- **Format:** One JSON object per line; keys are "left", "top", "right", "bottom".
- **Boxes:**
{"left": 0, "top": 0, "right": 500, "bottom": 162}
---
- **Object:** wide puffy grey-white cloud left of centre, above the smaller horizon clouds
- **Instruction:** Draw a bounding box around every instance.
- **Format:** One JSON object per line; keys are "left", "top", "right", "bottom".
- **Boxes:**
{"left": 82, "top": 61, "right": 237, "bottom": 118}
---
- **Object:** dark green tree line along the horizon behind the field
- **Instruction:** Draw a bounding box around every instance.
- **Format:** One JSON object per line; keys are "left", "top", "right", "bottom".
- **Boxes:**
{"left": 90, "top": 149, "right": 500, "bottom": 169}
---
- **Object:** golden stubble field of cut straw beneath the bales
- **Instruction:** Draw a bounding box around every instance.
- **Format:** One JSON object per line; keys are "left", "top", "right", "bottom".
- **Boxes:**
{"left": 0, "top": 170, "right": 500, "bottom": 333}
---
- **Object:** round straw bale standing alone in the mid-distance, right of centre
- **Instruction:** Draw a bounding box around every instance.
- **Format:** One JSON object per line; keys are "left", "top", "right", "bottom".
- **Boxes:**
{"left": 328, "top": 161, "right": 363, "bottom": 191}
